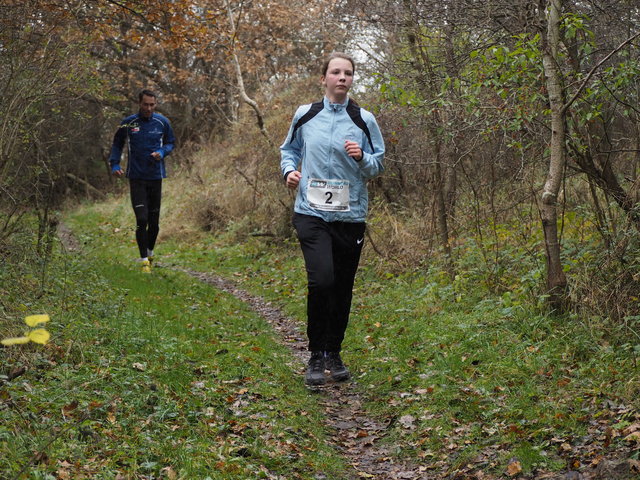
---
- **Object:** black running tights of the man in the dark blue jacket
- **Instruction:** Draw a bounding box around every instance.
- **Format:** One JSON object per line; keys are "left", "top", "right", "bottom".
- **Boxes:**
{"left": 129, "top": 178, "right": 162, "bottom": 258}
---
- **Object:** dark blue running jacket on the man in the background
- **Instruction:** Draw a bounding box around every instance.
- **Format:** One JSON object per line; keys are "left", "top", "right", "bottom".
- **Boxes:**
{"left": 109, "top": 113, "right": 176, "bottom": 180}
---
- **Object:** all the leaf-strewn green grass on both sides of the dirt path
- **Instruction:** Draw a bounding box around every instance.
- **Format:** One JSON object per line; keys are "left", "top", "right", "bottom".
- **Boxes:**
{"left": 0, "top": 194, "right": 640, "bottom": 479}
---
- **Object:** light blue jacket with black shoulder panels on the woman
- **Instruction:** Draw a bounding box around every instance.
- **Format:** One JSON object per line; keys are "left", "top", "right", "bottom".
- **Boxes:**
{"left": 280, "top": 97, "right": 384, "bottom": 223}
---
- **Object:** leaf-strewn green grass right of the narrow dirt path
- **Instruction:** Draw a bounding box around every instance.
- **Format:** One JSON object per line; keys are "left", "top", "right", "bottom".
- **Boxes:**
{"left": 151, "top": 210, "right": 640, "bottom": 475}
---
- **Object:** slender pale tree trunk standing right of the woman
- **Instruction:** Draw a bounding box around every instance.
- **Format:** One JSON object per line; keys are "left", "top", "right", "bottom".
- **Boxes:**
{"left": 541, "top": 0, "right": 567, "bottom": 309}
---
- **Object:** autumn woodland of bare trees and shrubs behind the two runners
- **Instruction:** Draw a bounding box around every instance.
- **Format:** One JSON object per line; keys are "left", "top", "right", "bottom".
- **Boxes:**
{"left": 0, "top": 0, "right": 640, "bottom": 478}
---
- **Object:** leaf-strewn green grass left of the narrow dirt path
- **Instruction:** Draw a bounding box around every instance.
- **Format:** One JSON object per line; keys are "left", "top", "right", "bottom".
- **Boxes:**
{"left": 0, "top": 209, "right": 348, "bottom": 479}
